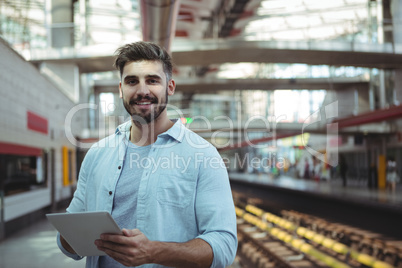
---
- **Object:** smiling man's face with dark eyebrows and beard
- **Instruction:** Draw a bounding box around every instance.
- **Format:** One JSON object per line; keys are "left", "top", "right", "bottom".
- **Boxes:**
{"left": 119, "top": 61, "right": 175, "bottom": 124}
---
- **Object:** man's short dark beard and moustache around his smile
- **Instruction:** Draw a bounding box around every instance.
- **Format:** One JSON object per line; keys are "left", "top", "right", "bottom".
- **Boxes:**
{"left": 123, "top": 88, "right": 168, "bottom": 125}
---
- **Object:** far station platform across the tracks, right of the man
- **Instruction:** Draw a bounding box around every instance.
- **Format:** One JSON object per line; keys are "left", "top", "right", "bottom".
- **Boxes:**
{"left": 229, "top": 173, "right": 402, "bottom": 212}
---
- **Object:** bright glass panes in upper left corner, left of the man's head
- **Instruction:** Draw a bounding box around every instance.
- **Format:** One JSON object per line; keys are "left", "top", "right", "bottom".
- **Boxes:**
{"left": 0, "top": 0, "right": 141, "bottom": 51}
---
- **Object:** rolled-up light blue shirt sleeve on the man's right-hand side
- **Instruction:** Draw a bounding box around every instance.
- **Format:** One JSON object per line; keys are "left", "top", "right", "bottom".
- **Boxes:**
{"left": 195, "top": 152, "right": 237, "bottom": 267}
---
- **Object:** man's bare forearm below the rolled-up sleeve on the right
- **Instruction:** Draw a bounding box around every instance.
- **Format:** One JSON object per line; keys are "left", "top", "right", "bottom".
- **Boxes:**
{"left": 152, "top": 238, "right": 214, "bottom": 268}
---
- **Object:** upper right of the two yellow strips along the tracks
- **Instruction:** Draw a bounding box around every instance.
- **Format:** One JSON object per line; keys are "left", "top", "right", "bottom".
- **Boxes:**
{"left": 246, "top": 205, "right": 394, "bottom": 268}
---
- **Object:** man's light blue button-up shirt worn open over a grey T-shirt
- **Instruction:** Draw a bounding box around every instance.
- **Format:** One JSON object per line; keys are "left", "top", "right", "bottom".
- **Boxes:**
{"left": 57, "top": 120, "right": 237, "bottom": 268}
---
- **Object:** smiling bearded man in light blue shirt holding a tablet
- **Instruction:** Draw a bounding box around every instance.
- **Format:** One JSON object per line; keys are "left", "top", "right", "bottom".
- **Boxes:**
{"left": 58, "top": 42, "right": 237, "bottom": 267}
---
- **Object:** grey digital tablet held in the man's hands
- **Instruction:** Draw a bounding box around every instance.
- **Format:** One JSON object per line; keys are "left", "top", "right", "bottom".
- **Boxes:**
{"left": 46, "top": 211, "right": 122, "bottom": 256}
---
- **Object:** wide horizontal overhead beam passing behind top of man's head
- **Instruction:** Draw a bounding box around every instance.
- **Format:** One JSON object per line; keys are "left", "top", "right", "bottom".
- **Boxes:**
{"left": 30, "top": 40, "right": 402, "bottom": 73}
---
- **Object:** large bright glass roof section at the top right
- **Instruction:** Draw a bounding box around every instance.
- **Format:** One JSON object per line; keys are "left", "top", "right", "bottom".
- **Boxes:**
{"left": 245, "top": 0, "right": 370, "bottom": 42}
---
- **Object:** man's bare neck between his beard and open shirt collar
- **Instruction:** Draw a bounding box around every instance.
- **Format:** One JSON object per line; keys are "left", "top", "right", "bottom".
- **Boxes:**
{"left": 130, "top": 116, "right": 174, "bottom": 146}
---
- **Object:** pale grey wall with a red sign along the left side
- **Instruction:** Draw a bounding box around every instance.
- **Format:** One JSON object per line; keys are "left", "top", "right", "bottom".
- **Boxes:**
{"left": 0, "top": 39, "right": 82, "bottom": 221}
